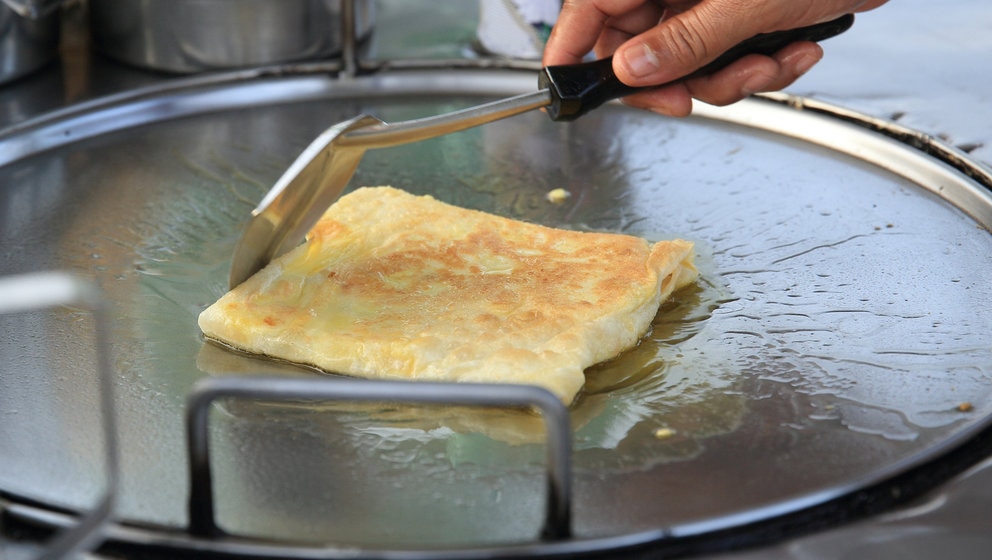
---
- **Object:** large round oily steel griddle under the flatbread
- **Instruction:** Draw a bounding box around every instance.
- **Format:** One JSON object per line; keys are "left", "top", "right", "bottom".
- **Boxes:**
{"left": 0, "top": 65, "right": 992, "bottom": 555}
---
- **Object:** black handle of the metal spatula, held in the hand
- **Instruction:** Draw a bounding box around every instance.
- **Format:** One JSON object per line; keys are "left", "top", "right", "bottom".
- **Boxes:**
{"left": 538, "top": 14, "right": 854, "bottom": 121}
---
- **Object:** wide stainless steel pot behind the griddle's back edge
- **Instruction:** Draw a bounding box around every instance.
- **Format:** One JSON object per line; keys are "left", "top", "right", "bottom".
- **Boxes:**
{"left": 90, "top": 0, "right": 373, "bottom": 73}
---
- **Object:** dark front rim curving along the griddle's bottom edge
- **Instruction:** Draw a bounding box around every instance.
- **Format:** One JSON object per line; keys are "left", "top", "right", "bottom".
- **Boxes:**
{"left": 0, "top": 426, "right": 992, "bottom": 560}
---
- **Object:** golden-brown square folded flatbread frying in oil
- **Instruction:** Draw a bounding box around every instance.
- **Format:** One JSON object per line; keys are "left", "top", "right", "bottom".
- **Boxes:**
{"left": 199, "top": 187, "right": 697, "bottom": 403}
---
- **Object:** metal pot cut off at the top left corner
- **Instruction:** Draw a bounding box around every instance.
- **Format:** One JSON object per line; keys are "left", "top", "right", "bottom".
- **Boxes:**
{"left": 0, "top": 0, "right": 62, "bottom": 83}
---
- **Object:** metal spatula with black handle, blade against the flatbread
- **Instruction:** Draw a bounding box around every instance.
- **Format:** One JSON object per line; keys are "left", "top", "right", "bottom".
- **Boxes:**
{"left": 230, "top": 15, "right": 854, "bottom": 288}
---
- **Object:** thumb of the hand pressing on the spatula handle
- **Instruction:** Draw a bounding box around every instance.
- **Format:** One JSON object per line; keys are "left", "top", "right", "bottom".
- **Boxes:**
{"left": 613, "top": 0, "right": 763, "bottom": 86}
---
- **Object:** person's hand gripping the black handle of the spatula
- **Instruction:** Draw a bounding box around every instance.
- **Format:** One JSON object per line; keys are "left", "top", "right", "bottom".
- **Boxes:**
{"left": 543, "top": 0, "right": 887, "bottom": 116}
